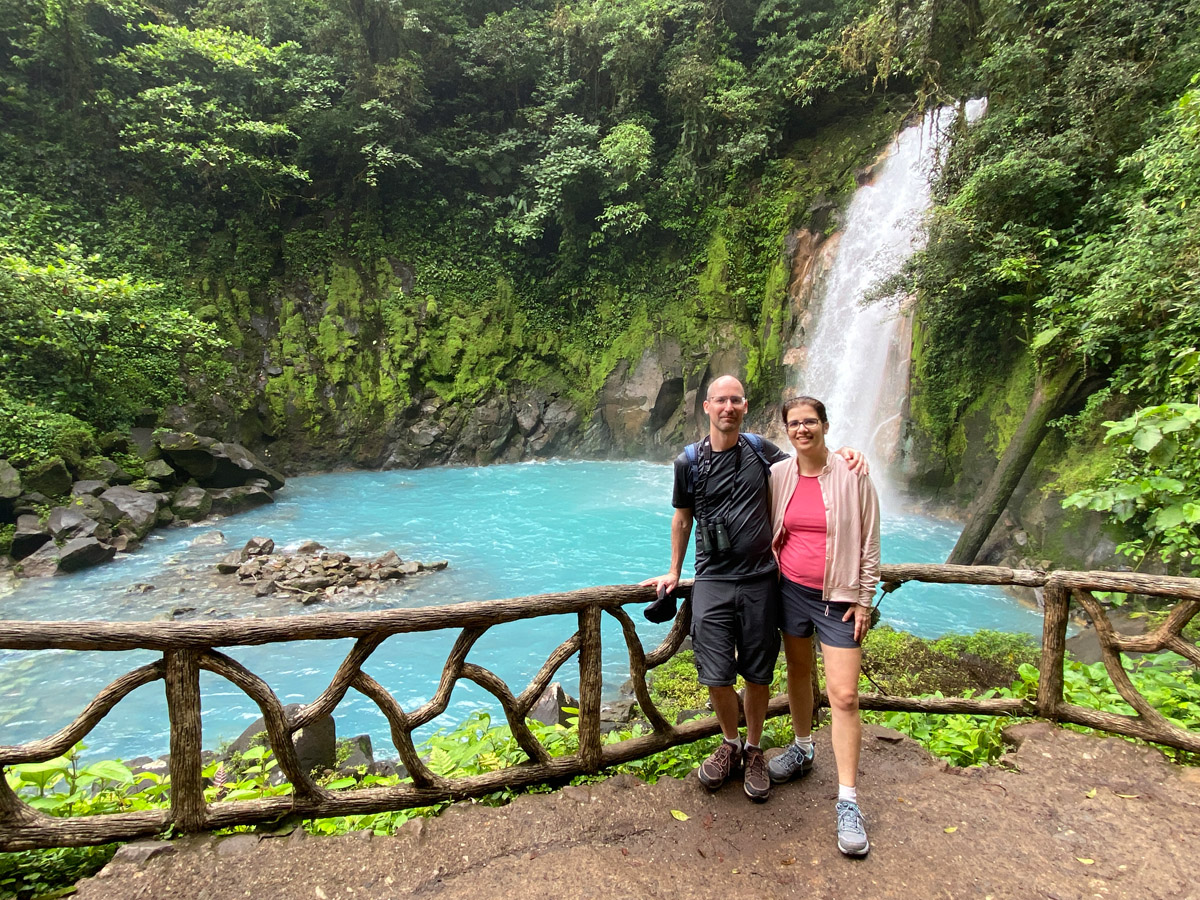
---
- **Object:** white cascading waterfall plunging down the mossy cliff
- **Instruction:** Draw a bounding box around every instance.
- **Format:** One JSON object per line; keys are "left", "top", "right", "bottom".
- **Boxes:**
{"left": 791, "top": 100, "right": 986, "bottom": 496}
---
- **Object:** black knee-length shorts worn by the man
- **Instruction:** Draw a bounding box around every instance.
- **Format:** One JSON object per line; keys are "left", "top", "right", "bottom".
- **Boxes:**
{"left": 691, "top": 574, "right": 779, "bottom": 688}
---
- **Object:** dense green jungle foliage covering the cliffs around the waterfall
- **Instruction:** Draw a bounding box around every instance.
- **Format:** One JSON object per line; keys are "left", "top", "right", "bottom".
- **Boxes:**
{"left": 0, "top": 0, "right": 1200, "bottom": 570}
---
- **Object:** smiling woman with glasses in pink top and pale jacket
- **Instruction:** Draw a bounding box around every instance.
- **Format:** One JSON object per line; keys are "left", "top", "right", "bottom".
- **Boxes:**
{"left": 768, "top": 397, "right": 880, "bottom": 856}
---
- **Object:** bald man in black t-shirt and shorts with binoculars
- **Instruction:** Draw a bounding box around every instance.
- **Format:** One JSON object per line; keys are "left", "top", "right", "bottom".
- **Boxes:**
{"left": 642, "top": 376, "right": 860, "bottom": 803}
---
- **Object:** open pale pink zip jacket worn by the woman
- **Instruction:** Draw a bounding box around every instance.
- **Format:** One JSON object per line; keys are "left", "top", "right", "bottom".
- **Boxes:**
{"left": 770, "top": 452, "right": 880, "bottom": 606}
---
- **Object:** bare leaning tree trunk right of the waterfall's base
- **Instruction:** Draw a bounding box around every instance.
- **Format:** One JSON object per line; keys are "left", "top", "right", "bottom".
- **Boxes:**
{"left": 946, "top": 368, "right": 1082, "bottom": 565}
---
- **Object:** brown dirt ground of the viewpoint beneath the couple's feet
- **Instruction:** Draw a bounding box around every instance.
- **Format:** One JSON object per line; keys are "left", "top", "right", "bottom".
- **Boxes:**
{"left": 78, "top": 722, "right": 1200, "bottom": 900}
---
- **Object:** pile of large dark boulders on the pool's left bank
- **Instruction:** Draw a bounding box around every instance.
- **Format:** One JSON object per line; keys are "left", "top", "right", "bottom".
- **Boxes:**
{"left": 0, "top": 428, "right": 284, "bottom": 577}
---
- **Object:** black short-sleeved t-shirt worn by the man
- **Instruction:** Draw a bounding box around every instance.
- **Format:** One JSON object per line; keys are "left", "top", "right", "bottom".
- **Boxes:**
{"left": 671, "top": 437, "right": 787, "bottom": 581}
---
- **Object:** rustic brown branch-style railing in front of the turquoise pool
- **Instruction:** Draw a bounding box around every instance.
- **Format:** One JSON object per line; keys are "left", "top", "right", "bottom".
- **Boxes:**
{"left": 0, "top": 565, "right": 1200, "bottom": 851}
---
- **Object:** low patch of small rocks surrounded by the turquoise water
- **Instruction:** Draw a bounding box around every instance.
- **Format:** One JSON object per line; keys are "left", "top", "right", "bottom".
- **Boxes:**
{"left": 217, "top": 538, "right": 449, "bottom": 605}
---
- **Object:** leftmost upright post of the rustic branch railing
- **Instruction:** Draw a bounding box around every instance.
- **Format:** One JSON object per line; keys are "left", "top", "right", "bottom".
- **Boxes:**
{"left": 164, "top": 650, "right": 206, "bottom": 832}
